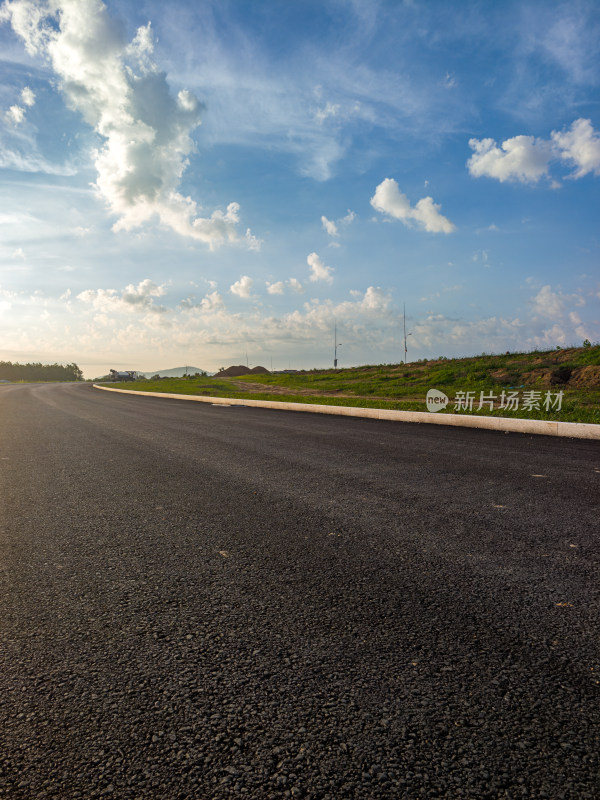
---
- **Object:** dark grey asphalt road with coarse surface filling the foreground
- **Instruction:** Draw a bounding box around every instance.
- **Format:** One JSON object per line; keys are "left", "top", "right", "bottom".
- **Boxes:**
{"left": 0, "top": 385, "right": 600, "bottom": 800}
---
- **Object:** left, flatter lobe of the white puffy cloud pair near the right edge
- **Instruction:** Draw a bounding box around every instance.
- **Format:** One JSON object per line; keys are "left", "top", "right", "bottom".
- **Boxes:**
{"left": 467, "top": 136, "right": 552, "bottom": 183}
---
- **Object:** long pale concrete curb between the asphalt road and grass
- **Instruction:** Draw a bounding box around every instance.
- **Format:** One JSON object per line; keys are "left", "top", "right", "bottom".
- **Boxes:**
{"left": 92, "top": 383, "right": 600, "bottom": 439}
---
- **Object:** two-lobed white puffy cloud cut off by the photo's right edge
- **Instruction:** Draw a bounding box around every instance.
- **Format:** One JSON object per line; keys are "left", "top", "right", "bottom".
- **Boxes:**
{"left": 467, "top": 119, "right": 600, "bottom": 188}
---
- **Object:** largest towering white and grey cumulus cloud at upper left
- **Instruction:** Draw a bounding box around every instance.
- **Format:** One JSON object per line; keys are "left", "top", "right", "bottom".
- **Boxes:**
{"left": 2, "top": 0, "right": 247, "bottom": 248}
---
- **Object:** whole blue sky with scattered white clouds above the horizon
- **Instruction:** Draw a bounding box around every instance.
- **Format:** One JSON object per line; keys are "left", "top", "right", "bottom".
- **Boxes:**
{"left": 0, "top": 0, "right": 600, "bottom": 377}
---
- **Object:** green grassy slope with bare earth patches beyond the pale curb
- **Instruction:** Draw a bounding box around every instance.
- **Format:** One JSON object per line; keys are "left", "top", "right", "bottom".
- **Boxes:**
{"left": 108, "top": 346, "right": 600, "bottom": 423}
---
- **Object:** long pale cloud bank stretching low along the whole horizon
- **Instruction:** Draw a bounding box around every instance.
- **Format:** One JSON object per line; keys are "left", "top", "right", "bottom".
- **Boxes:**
{"left": 0, "top": 281, "right": 600, "bottom": 377}
